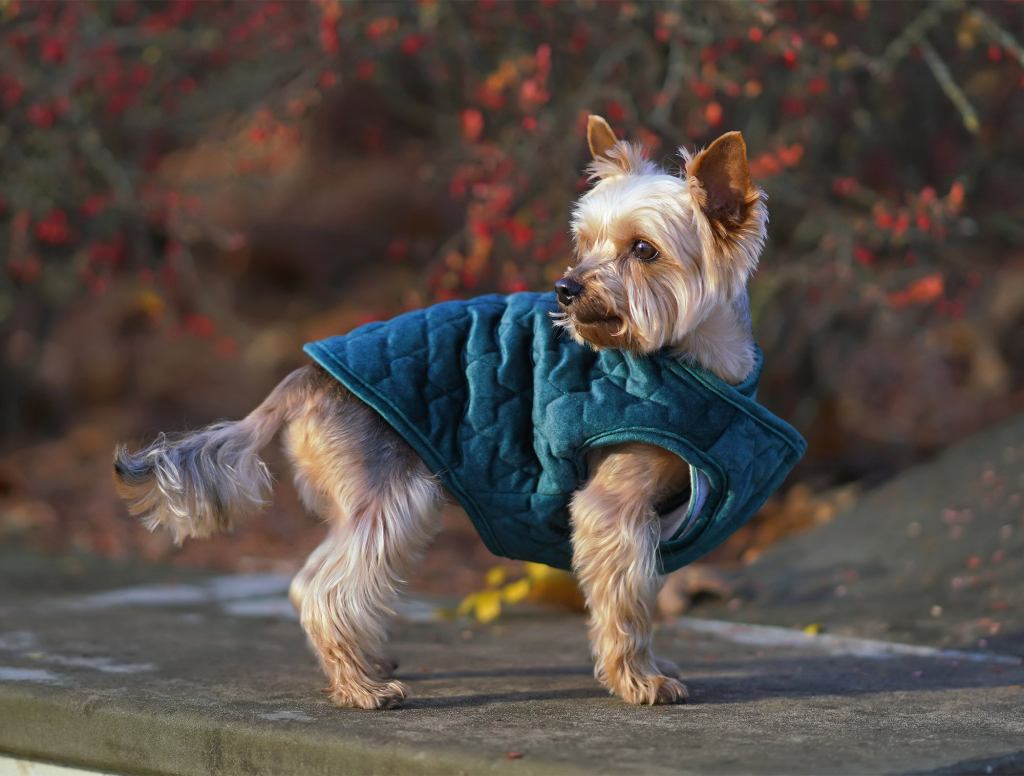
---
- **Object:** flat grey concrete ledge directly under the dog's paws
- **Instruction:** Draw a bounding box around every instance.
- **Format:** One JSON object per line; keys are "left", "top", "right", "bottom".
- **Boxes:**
{"left": 0, "top": 561, "right": 1024, "bottom": 776}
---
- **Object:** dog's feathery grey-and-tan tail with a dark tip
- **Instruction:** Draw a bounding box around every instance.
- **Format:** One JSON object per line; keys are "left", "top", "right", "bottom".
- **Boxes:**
{"left": 114, "top": 368, "right": 309, "bottom": 544}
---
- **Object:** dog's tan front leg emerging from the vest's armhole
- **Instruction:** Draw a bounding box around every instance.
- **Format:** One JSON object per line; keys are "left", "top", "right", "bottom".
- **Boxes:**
{"left": 571, "top": 445, "right": 687, "bottom": 704}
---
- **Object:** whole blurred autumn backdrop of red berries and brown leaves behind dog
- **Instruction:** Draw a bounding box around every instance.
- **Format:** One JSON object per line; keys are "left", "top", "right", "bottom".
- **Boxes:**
{"left": 0, "top": 0, "right": 1024, "bottom": 602}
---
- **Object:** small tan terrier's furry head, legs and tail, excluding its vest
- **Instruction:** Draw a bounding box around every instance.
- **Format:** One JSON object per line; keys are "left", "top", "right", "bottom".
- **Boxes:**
{"left": 115, "top": 116, "right": 767, "bottom": 708}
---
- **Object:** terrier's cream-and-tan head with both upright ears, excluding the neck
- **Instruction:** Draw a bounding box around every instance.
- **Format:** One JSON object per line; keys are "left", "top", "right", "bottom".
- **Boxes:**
{"left": 555, "top": 116, "right": 767, "bottom": 353}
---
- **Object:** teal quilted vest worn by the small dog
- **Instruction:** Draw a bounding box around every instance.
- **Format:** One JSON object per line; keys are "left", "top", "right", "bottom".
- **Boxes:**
{"left": 304, "top": 293, "right": 805, "bottom": 573}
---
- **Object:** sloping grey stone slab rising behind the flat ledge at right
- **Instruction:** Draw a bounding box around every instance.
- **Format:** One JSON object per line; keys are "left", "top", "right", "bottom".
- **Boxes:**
{"left": 700, "top": 416, "right": 1024, "bottom": 656}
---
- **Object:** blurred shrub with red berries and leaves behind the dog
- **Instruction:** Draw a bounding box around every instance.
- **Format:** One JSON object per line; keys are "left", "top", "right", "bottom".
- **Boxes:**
{"left": 0, "top": 0, "right": 1024, "bottom": 458}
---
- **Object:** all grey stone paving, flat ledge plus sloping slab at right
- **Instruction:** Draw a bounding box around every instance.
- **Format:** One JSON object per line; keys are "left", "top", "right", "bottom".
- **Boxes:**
{"left": 0, "top": 421, "right": 1024, "bottom": 776}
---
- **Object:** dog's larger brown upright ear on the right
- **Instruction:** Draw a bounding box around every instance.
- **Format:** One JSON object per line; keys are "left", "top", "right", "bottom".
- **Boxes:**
{"left": 686, "top": 132, "right": 759, "bottom": 228}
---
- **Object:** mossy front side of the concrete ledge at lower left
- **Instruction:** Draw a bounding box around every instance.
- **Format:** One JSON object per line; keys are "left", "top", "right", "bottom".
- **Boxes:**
{"left": 2, "top": 692, "right": 544, "bottom": 774}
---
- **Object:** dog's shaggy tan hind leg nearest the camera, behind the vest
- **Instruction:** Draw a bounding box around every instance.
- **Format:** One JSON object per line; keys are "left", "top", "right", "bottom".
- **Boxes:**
{"left": 287, "top": 376, "right": 441, "bottom": 708}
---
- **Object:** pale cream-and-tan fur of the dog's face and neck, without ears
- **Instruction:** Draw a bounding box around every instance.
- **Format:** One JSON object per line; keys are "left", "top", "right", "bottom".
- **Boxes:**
{"left": 556, "top": 141, "right": 767, "bottom": 383}
